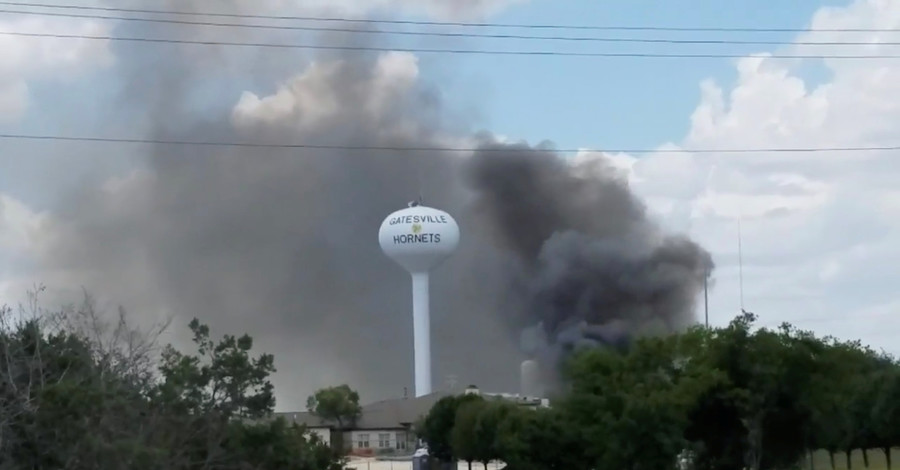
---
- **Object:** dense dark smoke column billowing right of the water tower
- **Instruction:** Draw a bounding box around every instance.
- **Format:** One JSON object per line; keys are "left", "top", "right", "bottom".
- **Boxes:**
{"left": 468, "top": 144, "right": 712, "bottom": 382}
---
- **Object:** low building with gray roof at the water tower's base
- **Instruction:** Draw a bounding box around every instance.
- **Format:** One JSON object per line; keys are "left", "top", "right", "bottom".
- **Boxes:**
{"left": 275, "top": 386, "right": 549, "bottom": 455}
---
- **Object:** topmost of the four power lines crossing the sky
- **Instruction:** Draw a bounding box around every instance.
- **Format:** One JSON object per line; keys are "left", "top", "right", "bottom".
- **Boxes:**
{"left": 0, "top": 1, "right": 900, "bottom": 33}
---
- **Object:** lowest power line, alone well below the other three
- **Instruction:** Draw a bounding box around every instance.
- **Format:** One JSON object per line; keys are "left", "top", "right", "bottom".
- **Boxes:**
{"left": 0, "top": 134, "right": 900, "bottom": 154}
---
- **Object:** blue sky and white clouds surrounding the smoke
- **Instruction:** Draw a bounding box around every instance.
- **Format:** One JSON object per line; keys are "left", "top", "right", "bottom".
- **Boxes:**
{"left": 0, "top": 0, "right": 900, "bottom": 404}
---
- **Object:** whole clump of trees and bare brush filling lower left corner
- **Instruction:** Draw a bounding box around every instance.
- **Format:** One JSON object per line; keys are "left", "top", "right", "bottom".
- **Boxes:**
{"left": 0, "top": 302, "right": 343, "bottom": 470}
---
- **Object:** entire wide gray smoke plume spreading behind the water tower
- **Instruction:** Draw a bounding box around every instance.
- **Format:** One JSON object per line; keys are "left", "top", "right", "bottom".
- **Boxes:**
{"left": 26, "top": 2, "right": 712, "bottom": 409}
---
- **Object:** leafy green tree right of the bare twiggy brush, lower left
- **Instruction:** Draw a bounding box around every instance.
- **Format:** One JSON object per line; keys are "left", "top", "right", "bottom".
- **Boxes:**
{"left": 150, "top": 319, "right": 343, "bottom": 470}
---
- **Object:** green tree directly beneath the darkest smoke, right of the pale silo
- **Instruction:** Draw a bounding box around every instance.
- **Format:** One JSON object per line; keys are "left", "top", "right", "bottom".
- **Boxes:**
{"left": 558, "top": 330, "right": 722, "bottom": 470}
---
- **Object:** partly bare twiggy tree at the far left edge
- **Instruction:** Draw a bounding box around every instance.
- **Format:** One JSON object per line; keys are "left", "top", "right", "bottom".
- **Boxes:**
{"left": 0, "top": 289, "right": 168, "bottom": 469}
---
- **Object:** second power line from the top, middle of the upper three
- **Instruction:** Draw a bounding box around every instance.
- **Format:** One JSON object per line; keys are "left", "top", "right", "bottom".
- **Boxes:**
{"left": 0, "top": 7, "right": 900, "bottom": 46}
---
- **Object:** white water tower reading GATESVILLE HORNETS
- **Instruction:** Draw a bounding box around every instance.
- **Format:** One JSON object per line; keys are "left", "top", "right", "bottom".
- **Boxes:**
{"left": 378, "top": 203, "right": 459, "bottom": 397}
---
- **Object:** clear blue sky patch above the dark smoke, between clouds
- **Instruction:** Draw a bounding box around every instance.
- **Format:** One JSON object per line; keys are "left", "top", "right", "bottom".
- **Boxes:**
{"left": 423, "top": 0, "right": 844, "bottom": 149}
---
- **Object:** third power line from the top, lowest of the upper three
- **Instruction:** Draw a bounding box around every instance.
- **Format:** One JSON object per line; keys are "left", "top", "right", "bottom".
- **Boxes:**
{"left": 0, "top": 31, "right": 900, "bottom": 60}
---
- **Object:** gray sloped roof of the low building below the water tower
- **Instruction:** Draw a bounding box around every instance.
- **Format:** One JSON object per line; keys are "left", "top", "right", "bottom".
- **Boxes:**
{"left": 275, "top": 392, "right": 450, "bottom": 430}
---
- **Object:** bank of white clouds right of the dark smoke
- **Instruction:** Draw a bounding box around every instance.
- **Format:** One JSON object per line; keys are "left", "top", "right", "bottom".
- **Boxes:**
{"left": 581, "top": 0, "right": 900, "bottom": 352}
